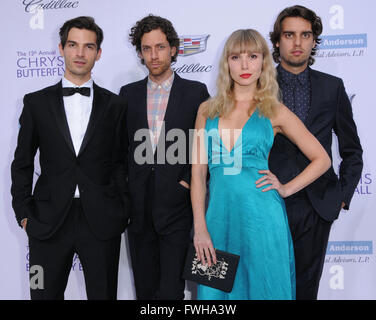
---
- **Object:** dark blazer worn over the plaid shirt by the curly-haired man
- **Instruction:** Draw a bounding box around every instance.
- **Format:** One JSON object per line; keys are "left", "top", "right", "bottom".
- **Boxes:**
{"left": 120, "top": 74, "right": 209, "bottom": 234}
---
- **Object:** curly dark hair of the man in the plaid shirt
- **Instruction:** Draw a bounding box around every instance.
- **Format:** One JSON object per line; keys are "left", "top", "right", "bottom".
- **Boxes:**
{"left": 129, "top": 14, "right": 179, "bottom": 64}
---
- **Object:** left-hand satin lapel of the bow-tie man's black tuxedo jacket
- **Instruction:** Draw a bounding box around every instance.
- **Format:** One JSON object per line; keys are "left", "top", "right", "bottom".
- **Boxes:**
{"left": 48, "top": 81, "right": 76, "bottom": 155}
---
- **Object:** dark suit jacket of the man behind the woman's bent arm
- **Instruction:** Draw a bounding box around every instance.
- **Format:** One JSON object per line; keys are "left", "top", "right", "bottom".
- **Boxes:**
{"left": 269, "top": 69, "right": 363, "bottom": 221}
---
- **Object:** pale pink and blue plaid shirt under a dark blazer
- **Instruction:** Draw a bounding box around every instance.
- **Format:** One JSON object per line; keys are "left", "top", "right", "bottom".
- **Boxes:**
{"left": 147, "top": 73, "right": 174, "bottom": 152}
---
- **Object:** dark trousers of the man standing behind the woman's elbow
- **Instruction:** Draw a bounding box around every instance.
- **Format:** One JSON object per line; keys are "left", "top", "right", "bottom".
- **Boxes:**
{"left": 285, "top": 191, "right": 332, "bottom": 300}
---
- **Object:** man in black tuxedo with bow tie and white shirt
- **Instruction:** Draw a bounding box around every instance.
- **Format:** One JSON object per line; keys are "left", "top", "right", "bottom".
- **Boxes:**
{"left": 11, "top": 17, "right": 128, "bottom": 299}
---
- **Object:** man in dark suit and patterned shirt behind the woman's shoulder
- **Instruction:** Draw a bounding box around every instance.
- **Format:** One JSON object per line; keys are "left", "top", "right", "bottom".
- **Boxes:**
{"left": 269, "top": 6, "right": 363, "bottom": 300}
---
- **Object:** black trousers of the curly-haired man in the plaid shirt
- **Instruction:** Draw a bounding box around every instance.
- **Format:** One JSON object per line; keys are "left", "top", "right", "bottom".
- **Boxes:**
{"left": 128, "top": 174, "right": 191, "bottom": 300}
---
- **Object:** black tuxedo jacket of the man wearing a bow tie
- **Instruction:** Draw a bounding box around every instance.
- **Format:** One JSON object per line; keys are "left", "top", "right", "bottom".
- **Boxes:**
{"left": 11, "top": 81, "right": 128, "bottom": 240}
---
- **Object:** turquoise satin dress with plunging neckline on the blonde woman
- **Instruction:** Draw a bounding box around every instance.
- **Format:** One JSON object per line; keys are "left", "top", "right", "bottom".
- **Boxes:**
{"left": 197, "top": 110, "right": 295, "bottom": 300}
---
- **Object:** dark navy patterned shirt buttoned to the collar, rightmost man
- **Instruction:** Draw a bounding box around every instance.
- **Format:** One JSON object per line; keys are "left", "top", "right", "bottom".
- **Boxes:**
{"left": 277, "top": 65, "right": 311, "bottom": 122}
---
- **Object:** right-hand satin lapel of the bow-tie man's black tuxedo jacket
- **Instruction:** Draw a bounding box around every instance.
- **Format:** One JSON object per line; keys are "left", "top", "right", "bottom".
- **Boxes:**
{"left": 78, "top": 83, "right": 108, "bottom": 156}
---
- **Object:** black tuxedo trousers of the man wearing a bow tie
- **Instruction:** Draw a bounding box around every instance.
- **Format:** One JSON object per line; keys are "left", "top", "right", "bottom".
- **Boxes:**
{"left": 29, "top": 199, "right": 120, "bottom": 300}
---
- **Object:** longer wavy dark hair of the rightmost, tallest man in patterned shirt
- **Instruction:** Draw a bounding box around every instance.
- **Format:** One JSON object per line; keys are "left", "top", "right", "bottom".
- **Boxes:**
{"left": 269, "top": 5, "right": 323, "bottom": 66}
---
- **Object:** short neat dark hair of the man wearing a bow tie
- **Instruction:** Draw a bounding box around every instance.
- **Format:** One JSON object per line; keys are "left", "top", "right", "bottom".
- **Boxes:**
{"left": 59, "top": 17, "right": 103, "bottom": 50}
